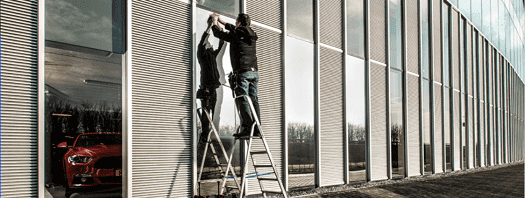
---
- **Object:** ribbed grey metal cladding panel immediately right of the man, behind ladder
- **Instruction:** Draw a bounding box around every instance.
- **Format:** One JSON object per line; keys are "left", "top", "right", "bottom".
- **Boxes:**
{"left": 247, "top": 25, "right": 284, "bottom": 194}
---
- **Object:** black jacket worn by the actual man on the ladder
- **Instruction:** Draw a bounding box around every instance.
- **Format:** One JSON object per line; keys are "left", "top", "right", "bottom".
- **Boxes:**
{"left": 212, "top": 23, "right": 258, "bottom": 71}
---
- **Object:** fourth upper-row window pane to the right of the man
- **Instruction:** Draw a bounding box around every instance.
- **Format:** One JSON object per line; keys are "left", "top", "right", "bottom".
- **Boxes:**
{"left": 420, "top": 0, "right": 430, "bottom": 79}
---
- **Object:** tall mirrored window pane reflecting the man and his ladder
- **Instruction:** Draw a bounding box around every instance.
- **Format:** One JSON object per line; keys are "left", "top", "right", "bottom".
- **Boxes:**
{"left": 194, "top": 8, "right": 241, "bottom": 196}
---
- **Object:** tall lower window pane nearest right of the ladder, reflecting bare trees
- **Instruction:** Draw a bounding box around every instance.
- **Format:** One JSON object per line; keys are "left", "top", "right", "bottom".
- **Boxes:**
{"left": 285, "top": 37, "right": 315, "bottom": 188}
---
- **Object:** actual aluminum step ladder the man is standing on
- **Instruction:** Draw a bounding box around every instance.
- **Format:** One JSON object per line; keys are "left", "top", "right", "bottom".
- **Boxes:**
{"left": 220, "top": 95, "right": 288, "bottom": 198}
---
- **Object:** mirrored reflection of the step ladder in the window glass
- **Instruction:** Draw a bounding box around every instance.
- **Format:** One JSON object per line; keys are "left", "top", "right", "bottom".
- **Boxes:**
{"left": 197, "top": 107, "right": 240, "bottom": 194}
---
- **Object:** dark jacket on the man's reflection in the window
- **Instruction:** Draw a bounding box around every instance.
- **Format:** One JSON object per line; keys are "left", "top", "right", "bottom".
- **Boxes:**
{"left": 197, "top": 32, "right": 224, "bottom": 89}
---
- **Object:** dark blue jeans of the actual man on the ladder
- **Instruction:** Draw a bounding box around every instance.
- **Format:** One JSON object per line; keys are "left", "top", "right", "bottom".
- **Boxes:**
{"left": 235, "top": 71, "right": 261, "bottom": 132}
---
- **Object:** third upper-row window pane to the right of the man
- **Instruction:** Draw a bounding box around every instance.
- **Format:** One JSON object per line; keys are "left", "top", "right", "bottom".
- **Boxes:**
{"left": 389, "top": 0, "right": 403, "bottom": 69}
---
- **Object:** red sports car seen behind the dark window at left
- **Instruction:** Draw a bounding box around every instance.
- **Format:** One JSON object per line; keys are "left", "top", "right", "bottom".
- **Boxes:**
{"left": 59, "top": 132, "right": 122, "bottom": 197}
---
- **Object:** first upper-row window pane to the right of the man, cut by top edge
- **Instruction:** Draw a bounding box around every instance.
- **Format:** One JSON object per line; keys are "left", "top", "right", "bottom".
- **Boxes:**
{"left": 286, "top": 0, "right": 314, "bottom": 41}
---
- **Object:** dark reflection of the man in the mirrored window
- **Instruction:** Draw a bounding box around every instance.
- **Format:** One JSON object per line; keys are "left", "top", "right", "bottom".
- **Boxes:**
{"left": 197, "top": 17, "right": 224, "bottom": 142}
